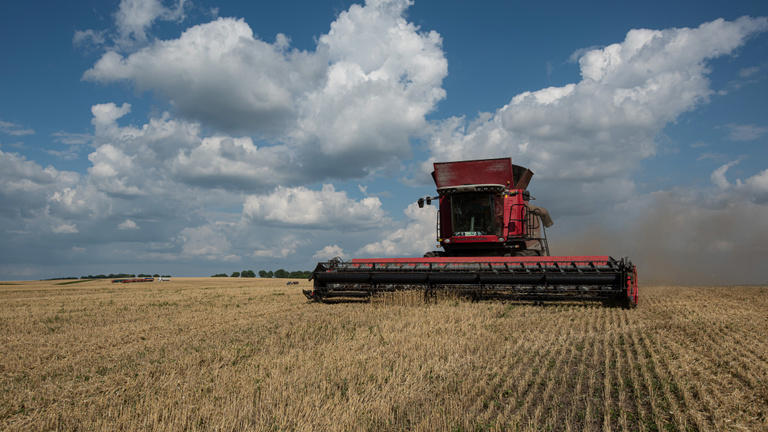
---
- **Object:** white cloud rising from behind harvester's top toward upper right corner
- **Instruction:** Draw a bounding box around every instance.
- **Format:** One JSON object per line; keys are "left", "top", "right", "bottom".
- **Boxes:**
{"left": 424, "top": 17, "right": 768, "bottom": 216}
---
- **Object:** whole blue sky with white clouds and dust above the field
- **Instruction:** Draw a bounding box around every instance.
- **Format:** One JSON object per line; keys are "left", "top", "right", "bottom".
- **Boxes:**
{"left": 0, "top": 0, "right": 768, "bottom": 283}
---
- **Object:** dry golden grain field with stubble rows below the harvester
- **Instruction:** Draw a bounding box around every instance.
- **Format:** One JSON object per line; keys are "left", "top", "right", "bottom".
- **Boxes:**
{"left": 0, "top": 278, "right": 768, "bottom": 431}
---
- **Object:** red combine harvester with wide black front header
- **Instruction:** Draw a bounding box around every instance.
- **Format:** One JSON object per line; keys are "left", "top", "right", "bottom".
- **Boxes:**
{"left": 304, "top": 158, "right": 638, "bottom": 307}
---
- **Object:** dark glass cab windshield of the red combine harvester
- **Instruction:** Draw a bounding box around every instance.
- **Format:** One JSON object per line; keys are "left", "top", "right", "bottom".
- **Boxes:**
{"left": 451, "top": 193, "right": 498, "bottom": 236}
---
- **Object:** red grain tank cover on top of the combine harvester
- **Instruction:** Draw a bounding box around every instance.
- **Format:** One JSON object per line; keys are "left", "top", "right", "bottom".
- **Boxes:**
{"left": 432, "top": 158, "right": 533, "bottom": 189}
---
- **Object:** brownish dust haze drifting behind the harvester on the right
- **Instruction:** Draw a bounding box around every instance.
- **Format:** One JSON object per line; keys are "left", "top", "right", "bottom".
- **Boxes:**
{"left": 550, "top": 192, "right": 768, "bottom": 285}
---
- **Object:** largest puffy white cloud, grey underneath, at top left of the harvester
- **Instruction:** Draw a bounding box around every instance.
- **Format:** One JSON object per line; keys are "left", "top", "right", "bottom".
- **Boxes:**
{"left": 83, "top": 0, "right": 447, "bottom": 180}
